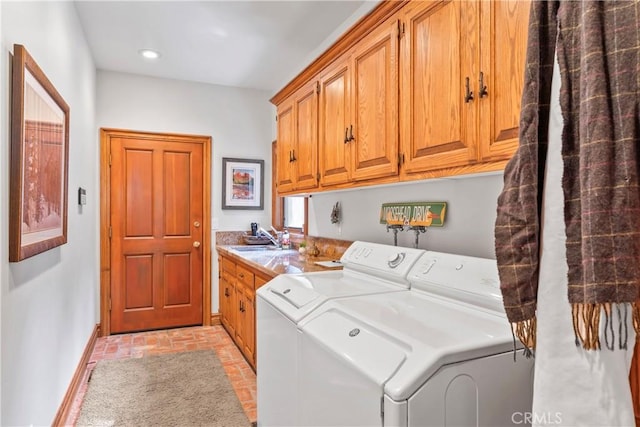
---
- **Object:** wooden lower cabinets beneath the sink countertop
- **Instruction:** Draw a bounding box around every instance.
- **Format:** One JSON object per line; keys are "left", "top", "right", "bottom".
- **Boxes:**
{"left": 218, "top": 255, "right": 271, "bottom": 370}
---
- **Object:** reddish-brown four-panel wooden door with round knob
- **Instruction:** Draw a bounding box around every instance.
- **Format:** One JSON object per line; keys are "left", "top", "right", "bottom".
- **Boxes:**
{"left": 109, "top": 133, "right": 209, "bottom": 333}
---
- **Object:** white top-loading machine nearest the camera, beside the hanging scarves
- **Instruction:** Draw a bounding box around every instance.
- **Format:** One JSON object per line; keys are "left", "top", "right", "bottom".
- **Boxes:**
{"left": 297, "top": 252, "right": 533, "bottom": 427}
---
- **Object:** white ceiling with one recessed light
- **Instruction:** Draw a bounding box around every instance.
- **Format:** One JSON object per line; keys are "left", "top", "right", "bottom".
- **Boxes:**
{"left": 75, "top": 0, "right": 364, "bottom": 92}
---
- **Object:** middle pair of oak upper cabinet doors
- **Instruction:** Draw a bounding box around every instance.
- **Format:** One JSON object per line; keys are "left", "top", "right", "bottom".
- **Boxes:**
{"left": 319, "top": 18, "right": 398, "bottom": 186}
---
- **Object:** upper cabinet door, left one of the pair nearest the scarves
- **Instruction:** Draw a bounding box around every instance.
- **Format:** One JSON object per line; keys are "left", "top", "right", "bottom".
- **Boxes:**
{"left": 400, "top": 1, "right": 478, "bottom": 173}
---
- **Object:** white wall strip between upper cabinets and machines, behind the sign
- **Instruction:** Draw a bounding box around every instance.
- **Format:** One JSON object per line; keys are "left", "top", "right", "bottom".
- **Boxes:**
{"left": 309, "top": 173, "right": 502, "bottom": 259}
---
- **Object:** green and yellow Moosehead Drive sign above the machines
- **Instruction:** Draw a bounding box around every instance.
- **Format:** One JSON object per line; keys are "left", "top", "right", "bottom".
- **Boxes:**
{"left": 380, "top": 202, "right": 447, "bottom": 227}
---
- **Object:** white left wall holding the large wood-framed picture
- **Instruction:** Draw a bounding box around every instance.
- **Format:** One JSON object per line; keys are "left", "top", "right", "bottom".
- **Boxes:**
{"left": 0, "top": 2, "right": 99, "bottom": 425}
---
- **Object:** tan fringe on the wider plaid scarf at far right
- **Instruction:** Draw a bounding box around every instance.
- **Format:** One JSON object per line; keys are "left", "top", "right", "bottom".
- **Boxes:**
{"left": 571, "top": 302, "right": 640, "bottom": 350}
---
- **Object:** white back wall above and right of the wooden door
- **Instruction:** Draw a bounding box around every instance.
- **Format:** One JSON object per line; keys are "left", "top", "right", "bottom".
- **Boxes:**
{"left": 97, "top": 71, "right": 275, "bottom": 313}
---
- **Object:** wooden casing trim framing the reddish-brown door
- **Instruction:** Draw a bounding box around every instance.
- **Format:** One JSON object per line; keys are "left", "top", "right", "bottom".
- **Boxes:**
{"left": 100, "top": 128, "right": 212, "bottom": 336}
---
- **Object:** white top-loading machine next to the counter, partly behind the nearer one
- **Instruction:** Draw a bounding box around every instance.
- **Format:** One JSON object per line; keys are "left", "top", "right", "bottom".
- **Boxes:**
{"left": 256, "top": 241, "right": 425, "bottom": 426}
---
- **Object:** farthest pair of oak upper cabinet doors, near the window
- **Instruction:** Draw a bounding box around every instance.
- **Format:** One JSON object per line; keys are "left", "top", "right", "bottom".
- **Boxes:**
{"left": 277, "top": 81, "right": 318, "bottom": 193}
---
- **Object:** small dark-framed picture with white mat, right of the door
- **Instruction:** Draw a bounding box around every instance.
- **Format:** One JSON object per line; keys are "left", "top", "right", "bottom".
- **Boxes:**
{"left": 222, "top": 157, "right": 264, "bottom": 210}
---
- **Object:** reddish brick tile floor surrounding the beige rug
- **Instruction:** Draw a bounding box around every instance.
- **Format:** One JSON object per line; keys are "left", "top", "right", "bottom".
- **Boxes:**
{"left": 65, "top": 325, "right": 256, "bottom": 425}
